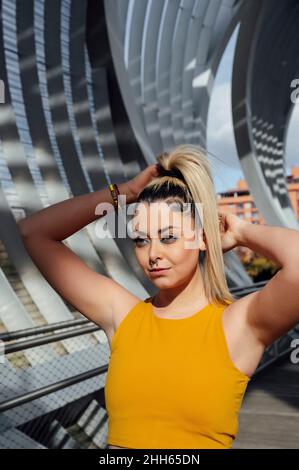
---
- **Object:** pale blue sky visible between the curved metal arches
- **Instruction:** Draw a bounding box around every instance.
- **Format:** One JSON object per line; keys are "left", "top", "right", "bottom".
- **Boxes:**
{"left": 207, "top": 26, "right": 299, "bottom": 192}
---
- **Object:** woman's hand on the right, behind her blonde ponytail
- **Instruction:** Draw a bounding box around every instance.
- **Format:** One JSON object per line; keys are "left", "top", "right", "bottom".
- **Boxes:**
{"left": 218, "top": 211, "right": 249, "bottom": 253}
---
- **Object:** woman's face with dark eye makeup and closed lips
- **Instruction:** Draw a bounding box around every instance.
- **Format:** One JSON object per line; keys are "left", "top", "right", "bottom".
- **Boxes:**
{"left": 130, "top": 202, "right": 205, "bottom": 289}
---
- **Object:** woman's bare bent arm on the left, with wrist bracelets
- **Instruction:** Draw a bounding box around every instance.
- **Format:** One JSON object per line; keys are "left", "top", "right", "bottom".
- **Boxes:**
{"left": 18, "top": 183, "right": 140, "bottom": 331}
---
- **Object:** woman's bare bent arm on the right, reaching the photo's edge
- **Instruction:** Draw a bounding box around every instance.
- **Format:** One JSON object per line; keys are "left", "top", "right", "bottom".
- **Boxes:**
{"left": 237, "top": 222, "right": 299, "bottom": 346}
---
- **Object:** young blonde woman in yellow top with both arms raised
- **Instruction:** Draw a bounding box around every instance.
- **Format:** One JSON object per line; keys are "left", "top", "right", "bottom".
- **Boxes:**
{"left": 19, "top": 144, "right": 299, "bottom": 449}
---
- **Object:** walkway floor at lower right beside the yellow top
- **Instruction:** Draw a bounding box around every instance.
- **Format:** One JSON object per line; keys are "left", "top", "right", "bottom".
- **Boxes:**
{"left": 233, "top": 357, "right": 299, "bottom": 449}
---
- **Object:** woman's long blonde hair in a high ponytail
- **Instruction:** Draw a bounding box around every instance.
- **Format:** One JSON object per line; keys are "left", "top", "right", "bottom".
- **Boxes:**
{"left": 137, "top": 144, "right": 235, "bottom": 305}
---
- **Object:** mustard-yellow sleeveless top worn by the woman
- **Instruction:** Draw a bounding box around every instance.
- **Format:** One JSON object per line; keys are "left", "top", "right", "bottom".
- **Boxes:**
{"left": 105, "top": 298, "right": 251, "bottom": 449}
